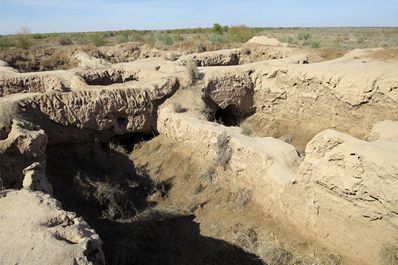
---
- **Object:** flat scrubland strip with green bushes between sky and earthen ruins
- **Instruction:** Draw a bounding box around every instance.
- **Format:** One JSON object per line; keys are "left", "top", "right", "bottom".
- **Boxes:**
{"left": 0, "top": 26, "right": 398, "bottom": 52}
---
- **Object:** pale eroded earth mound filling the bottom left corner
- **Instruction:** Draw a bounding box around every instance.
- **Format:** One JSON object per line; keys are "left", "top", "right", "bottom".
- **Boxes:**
{"left": 0, "top": 190, "right": 105, "bottom": 265}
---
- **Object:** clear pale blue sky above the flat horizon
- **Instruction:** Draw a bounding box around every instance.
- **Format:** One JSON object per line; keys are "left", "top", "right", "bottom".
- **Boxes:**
{"left": 0, "top": 0, "right": 398, "bottom": 34}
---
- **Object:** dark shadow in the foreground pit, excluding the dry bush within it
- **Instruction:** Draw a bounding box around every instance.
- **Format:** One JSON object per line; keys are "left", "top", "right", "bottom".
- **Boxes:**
{"left": 47, "top": 140, "right": 265, "bottom": 265}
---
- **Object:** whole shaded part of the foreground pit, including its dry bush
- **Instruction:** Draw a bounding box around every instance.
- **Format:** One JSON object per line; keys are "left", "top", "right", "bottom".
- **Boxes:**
{"left": 46, "top": 134, "right": 263, "bottom": 265}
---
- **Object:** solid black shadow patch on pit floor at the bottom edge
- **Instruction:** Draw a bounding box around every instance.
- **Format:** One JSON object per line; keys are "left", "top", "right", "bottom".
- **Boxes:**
{"left": 92, "top": 212, "right": 265, "bottom": 265}
